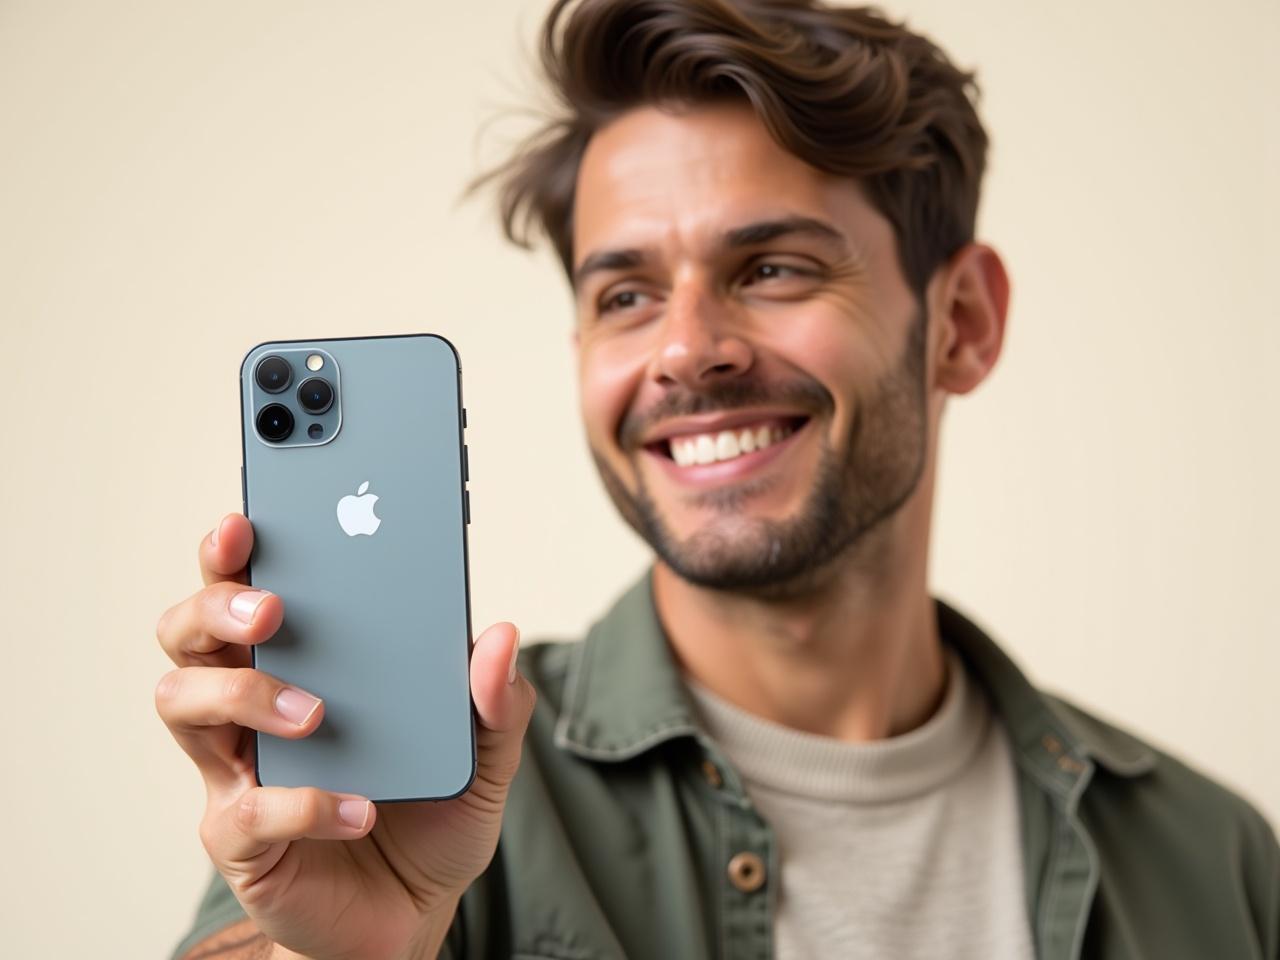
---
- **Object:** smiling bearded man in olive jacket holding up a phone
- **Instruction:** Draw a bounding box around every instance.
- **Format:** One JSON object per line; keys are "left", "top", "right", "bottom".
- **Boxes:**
{"left": 156, "top": 0, "right": 1280, "bottom": 960}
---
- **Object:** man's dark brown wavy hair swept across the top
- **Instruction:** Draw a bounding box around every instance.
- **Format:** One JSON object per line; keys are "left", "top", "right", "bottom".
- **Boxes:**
{"left": 471, "top": 0, "right": 987, "bottom": 296}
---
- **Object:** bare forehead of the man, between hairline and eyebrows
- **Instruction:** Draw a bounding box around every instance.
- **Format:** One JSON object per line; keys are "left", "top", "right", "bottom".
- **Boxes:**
{"left": 573, "top": 104, "right": 869, "bottom": 262}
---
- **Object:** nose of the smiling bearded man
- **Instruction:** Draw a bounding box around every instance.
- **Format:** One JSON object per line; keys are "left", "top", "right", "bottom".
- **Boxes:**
{"left": 649, "top": 287, "right": 755, "bottom": 390}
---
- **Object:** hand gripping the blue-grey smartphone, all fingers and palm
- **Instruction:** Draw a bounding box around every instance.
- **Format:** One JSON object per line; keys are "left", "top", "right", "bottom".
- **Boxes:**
{"left": 156, "top": 513, "right": 534, "bottom": 960}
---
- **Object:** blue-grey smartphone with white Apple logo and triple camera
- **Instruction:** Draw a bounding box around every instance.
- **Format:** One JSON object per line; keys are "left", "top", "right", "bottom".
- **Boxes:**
{"left": 241, "top": 334, "right": 476, "bottom": 801}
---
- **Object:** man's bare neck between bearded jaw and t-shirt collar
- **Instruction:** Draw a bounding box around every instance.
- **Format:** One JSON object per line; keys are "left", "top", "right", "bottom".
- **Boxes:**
{"left": 653, "top": 476, "right": 946, "bottom": 742}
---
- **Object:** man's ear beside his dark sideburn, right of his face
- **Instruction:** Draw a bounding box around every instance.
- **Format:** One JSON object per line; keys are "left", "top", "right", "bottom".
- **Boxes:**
{"left": 934, "top": 243, "right": 1009, "bottom": 394}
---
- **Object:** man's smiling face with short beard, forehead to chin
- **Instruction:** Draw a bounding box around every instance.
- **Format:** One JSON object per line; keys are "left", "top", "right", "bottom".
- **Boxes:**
{"left": 573, "top": 99, "right": 928, "bottom": 590}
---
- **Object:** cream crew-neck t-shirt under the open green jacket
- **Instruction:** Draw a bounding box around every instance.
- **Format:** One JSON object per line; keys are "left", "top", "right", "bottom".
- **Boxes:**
{"left": 686, "top": 650, "right": 1034, "bottom": 960}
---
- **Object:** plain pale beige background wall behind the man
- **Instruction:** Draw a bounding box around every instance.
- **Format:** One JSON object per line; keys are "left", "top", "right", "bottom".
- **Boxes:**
{"left": 0, "top": 0, "right": 1280, "bottom": 957}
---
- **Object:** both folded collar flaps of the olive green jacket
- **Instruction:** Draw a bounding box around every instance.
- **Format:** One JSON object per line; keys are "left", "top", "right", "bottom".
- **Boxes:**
{"left": 556, "top": 573, "right": 1155, "bottom": 796}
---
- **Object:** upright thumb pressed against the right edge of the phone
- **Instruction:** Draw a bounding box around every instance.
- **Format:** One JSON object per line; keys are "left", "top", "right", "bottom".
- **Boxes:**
{"left": 471, "top": 623, "right": 536, "bottom": 800}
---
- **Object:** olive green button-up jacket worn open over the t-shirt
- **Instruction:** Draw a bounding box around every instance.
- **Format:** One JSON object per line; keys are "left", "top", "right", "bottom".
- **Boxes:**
{"left": 172, "top": 577, "right": 1280, "bottom": 960}
